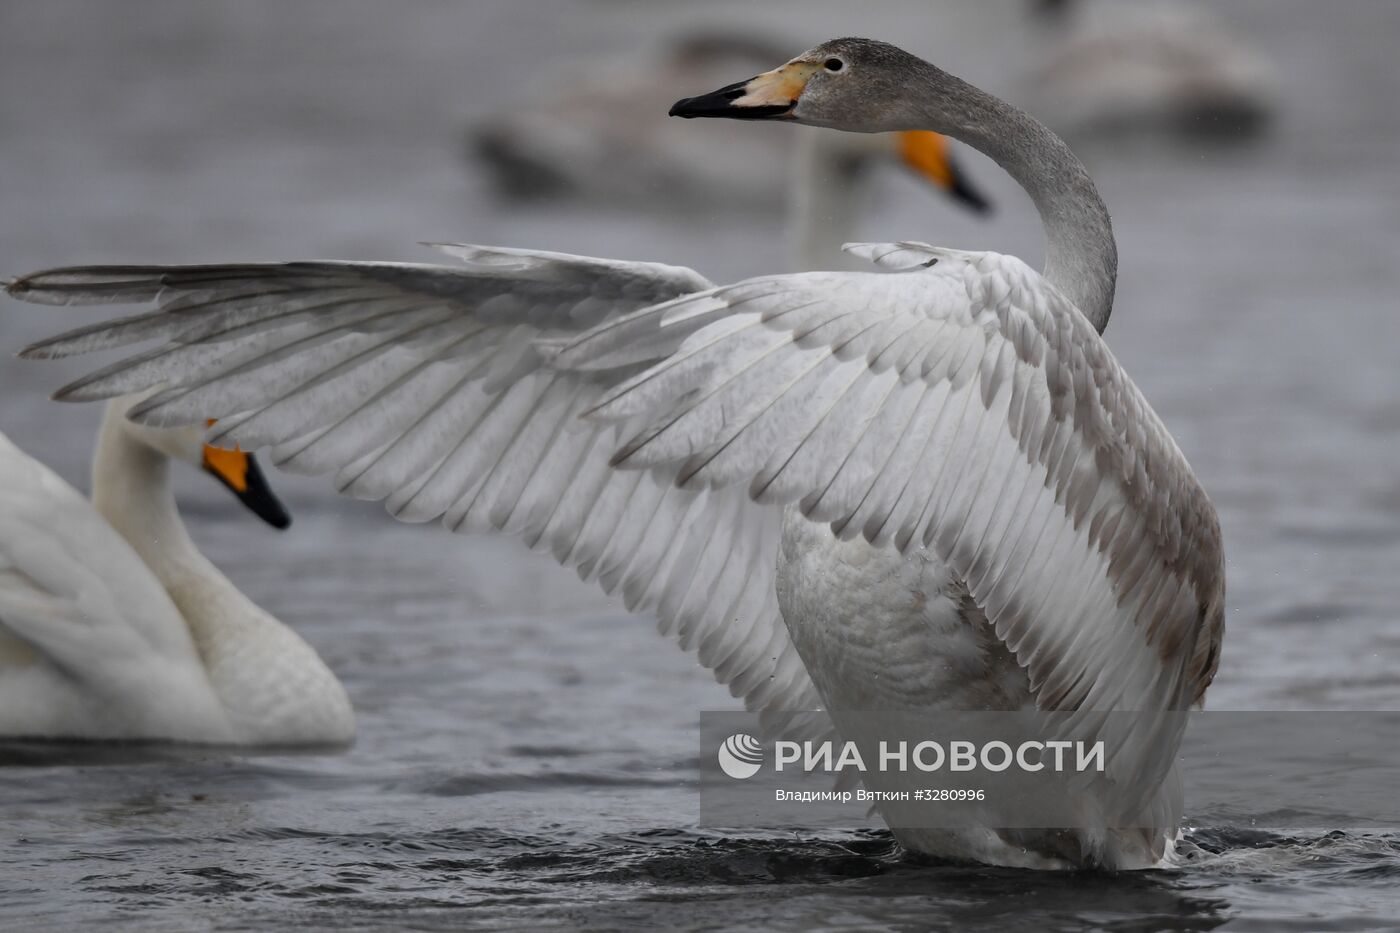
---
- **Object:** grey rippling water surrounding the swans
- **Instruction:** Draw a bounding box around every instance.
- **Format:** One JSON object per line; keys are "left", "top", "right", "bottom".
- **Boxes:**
{"left": 0, "top": 0, "right": 1400, "bottom": 930}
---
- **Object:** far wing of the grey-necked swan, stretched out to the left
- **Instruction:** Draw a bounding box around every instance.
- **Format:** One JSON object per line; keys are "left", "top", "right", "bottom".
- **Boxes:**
{"left": 8, "top": 247, "right": 820, "bottom": 728}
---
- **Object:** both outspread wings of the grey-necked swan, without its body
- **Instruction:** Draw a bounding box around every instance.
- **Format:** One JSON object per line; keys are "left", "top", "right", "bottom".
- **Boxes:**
{"left": 10, "top": 244, "right": 1224, "bottom": 787}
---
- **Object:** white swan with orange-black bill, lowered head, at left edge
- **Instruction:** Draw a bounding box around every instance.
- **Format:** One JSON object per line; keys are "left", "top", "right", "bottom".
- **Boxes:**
{"left": 0, "top": 396, "right": 354, "bottom": 745}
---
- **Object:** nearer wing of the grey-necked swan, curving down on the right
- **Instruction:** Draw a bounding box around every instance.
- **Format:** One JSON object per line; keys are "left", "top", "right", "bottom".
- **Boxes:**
{"left": 554, "top": 244, "right": 1224, "bottom": 803}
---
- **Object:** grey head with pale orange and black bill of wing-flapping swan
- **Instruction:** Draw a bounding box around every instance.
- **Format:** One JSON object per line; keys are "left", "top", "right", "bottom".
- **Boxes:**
{"left": 671, "top": 39, "right": 942, "bottom": 133}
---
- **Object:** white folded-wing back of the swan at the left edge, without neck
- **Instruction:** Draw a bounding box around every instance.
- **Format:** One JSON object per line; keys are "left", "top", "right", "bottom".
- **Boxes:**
{"left": 0, "top": 434, "right": 225, "bottom": 741}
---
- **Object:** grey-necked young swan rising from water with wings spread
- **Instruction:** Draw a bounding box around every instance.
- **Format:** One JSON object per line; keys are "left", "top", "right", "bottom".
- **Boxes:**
{"left": 7, "top": 39, "right": 1225, "bottom": 869}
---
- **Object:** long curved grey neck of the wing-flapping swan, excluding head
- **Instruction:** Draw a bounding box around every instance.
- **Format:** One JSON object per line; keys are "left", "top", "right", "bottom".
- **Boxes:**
{"left": 918, "top": 66, "right": 1119, "bottom": 326}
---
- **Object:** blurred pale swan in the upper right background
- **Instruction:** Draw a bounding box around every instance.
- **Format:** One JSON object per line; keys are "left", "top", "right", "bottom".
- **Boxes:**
{"left": 1026, "top": 0, "right": 1277, "bottom": 139}
